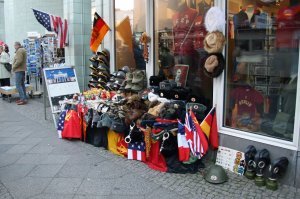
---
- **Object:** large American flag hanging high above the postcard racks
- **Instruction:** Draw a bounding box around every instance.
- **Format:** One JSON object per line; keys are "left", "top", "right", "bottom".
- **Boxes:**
{"left": 32, "top": 9, "right": 68, "bottom": 48}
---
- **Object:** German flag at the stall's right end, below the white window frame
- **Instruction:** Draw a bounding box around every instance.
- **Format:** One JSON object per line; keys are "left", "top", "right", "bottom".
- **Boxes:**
{"left": 200, "top": 107, "right": 219, "bottom": 149}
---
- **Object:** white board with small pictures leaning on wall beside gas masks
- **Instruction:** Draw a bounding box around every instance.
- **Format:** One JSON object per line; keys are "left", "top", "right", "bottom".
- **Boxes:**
{"left": 216, "top": 146, "right": 245, "bottom": 175}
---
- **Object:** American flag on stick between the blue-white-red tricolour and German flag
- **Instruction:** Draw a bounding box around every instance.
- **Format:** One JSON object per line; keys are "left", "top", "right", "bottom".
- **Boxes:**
{"left": 185, "top": 111, "right": 208, "bottom": 159}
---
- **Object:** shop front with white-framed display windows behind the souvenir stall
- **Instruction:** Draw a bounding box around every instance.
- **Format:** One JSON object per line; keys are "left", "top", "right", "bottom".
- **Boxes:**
{"left": 88, "top": 0, "right": 300, "bottom": 187}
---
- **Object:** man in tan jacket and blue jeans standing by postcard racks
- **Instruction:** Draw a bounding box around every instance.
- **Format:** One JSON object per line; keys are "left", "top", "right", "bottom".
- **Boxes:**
{"left": 12, "top": 42, "right": 28, "bottom": 105}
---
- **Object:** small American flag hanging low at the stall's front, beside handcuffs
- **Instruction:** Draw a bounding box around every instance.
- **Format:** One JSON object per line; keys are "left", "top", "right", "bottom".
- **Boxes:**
{"left": 127, "top": 142, "right": 146, "bottom": 162}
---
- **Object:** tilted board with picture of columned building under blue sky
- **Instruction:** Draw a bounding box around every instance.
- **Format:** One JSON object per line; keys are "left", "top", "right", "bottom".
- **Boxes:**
{"left": 44, "top": 67, "right": 80, "bottom": 113}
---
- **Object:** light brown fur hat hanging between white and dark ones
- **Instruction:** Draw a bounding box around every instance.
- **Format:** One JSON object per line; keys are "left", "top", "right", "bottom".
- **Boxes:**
{"left": 204, "top": 31, "right": 226, "bottom": 53}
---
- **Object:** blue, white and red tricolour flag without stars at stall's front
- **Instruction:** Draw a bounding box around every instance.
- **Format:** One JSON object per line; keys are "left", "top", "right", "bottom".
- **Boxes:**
{"left": 177, "top": 121, "right": 190, "bottom": 162}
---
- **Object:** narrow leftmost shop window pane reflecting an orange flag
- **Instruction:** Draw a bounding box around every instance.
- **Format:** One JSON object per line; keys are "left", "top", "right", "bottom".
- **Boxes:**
{"left": 115, "top": 0, "right": 146, "bottom": 69}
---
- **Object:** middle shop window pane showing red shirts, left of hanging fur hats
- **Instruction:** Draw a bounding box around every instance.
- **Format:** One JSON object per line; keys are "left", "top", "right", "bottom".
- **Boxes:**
{"left": 154, "top": 0, "right": 213, "bottom": 106}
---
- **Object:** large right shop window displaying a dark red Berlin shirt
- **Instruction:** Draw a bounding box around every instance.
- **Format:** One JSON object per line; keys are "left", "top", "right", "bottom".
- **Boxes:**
{"left": 224, "top": 0, "right": 300, "bottom": 141}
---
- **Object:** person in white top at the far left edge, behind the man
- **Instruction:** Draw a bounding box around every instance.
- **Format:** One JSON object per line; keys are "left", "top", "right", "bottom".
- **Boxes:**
{"left": 0, "top": 46, "right": 11, "bottom": 97}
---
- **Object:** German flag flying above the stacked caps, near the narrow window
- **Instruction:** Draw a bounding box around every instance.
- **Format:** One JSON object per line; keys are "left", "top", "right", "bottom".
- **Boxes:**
{"left": 90, "top": 12, "right": 110, "bottom": 52}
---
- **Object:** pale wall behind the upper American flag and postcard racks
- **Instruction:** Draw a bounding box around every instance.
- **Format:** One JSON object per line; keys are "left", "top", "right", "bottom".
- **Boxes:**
{"left": 0, "top": 0, "right": 63, "bottom": 48}
